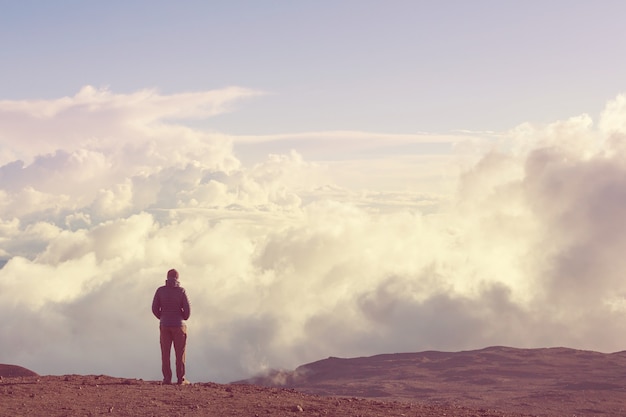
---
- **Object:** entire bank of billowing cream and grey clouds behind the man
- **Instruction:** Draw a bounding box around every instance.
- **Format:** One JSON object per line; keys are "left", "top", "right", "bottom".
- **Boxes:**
{"left": 0, "top": 87, "right": 626, "bottom": 382}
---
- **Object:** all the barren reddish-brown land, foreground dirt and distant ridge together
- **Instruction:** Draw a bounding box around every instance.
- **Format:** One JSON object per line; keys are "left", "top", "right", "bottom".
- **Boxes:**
{"left": 0, "top": 347, "right": 626, "bottom": 417}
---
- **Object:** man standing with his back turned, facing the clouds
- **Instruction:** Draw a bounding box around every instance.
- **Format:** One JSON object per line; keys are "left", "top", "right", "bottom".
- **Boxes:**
{"left": 152, "top": 269, "right": 191, "bottom": 385}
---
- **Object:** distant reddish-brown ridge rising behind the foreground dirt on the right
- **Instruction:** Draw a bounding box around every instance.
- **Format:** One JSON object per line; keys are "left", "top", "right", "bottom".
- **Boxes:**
{"left": 235, "top": 346, "right": 626, "bottom": 416}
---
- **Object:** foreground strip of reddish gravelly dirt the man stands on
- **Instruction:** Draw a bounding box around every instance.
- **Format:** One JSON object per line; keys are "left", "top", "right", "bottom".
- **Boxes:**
{"left": 0, "top": 375, "right": 524, "bottom": 417}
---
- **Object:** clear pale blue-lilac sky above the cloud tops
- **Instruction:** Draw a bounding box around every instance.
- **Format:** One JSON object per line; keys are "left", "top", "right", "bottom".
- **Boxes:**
{"left": 0, "top": 0, "right": 626, "bottom": 134}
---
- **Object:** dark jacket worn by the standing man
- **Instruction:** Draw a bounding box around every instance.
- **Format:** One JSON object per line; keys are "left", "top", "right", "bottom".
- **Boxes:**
{"left": 152, "top": 279, "right": 191, "bottom": 327}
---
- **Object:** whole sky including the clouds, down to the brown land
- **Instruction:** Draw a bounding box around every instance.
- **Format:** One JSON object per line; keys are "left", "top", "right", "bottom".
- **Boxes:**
{"left": 0, "top": 0, "right": 626, "bottom": 382}
